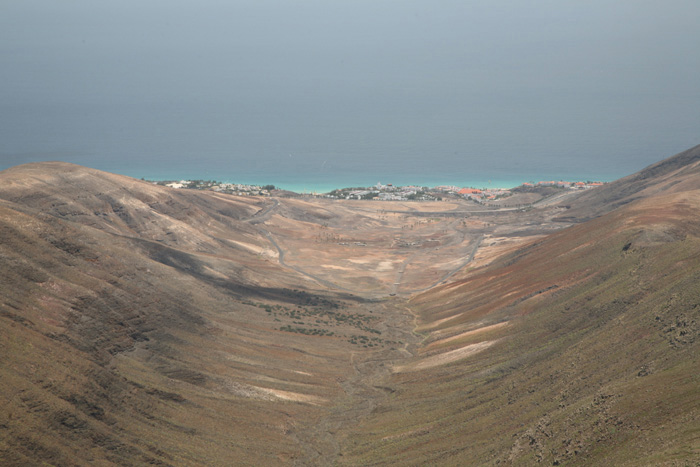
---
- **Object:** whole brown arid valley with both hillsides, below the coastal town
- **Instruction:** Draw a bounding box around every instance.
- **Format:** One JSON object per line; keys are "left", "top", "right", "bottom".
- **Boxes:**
{"left": 0, "top": 147, "right": 700, "bottom": 466}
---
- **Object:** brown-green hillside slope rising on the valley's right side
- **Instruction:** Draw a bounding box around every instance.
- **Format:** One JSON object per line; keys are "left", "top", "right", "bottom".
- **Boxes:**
{"left": 342, "top": 148, "right": 700, "bottom": 465}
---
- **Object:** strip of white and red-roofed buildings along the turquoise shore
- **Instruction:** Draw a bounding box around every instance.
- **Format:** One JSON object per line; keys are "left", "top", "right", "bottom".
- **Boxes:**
{"left": 151, "top": 180, "right": 604, "bottom": 204}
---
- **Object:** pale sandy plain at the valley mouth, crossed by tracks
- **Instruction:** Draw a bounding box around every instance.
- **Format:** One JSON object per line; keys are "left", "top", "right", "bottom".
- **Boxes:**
{"left": 256, "top": 198, "right": 580, "bottom": 298}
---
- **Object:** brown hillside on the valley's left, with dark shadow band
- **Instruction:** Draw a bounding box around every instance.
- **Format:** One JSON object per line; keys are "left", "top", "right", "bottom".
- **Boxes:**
{"left": 0, "top": 163, "right": 388, "bottom": 465}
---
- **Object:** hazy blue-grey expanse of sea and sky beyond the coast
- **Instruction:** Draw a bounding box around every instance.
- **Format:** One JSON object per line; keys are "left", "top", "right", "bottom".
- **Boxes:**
{"left": 0, "top": 0, "right": 700, "bottom": 185}
